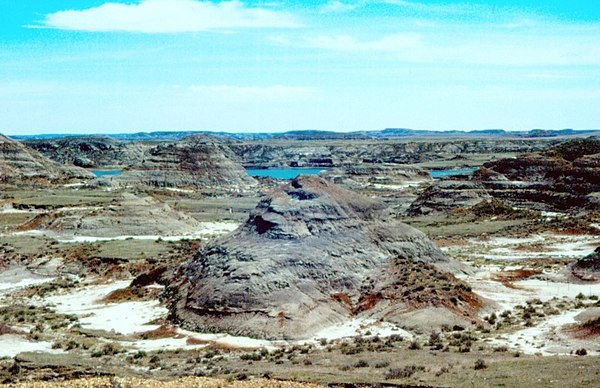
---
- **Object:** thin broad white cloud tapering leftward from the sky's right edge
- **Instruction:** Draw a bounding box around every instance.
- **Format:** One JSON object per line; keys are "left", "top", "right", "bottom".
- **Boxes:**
{"left": 300, "top": 25, "right": 600, "bottom": 66}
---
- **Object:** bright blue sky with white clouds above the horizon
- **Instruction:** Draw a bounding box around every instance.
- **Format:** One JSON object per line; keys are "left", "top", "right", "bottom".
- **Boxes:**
{"left": 0, "top": 0, "right": 600, "bottom": 135}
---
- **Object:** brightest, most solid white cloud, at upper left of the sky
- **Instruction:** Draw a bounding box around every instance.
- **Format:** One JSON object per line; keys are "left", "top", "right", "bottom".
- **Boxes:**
{"left": 42, "top": 0, "right": 300, "bottom": 33}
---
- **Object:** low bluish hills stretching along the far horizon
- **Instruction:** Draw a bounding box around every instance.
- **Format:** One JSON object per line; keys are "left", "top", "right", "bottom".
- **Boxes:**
{"left": 11, "top": 128, "right": 600, "bottom": 141}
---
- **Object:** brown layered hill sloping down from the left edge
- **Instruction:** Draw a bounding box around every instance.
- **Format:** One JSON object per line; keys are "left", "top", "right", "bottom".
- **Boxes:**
{"left": 0, "top": 135, "right": 94, "bottom": 184}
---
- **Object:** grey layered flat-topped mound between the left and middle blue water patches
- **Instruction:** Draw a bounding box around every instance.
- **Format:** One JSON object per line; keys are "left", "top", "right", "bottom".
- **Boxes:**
{"left": 114, "top": 136, "right": 256, "bottom": 192}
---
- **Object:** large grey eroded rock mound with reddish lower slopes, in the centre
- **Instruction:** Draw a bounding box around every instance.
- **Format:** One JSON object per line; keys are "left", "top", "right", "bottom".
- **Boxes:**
{"left": 165, "top": 176, "right": 479, "bottom": 338}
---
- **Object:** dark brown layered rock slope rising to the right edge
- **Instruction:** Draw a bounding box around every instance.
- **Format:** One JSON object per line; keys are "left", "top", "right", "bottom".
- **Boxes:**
{"left": 409, "top": 139, "right": 600, "bottom": 214}
